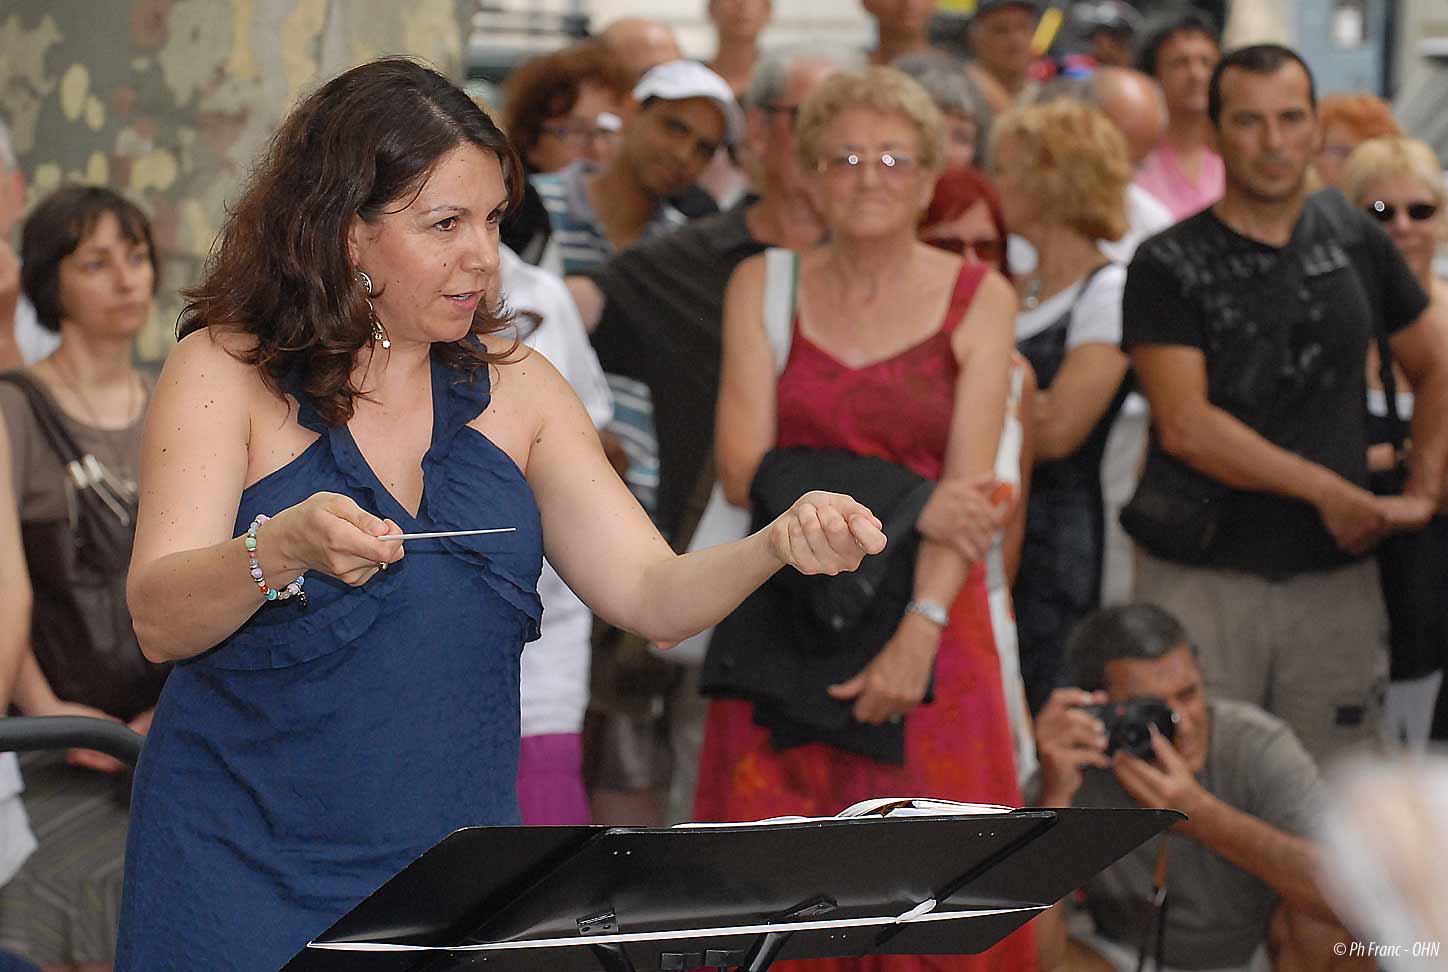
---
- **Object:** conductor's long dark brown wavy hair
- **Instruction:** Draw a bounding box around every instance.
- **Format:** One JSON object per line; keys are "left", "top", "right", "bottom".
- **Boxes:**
{"left": 177, "top": 58, "right": 521, "bottom": 426}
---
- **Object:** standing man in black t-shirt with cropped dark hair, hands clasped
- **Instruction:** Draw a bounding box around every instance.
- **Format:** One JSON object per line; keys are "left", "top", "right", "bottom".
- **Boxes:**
{"left": 1122, "top": 45, "right": 1448, "bottom": 762}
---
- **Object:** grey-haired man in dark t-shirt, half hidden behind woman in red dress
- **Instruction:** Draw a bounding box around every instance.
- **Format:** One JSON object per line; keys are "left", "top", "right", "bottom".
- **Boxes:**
{"left": 569, "top": 46, "right": 862, "bottom": 823}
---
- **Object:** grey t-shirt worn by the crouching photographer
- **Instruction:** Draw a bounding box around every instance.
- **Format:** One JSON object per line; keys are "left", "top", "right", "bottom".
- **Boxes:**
{"left": 1037, "top": 700, "right": 1323, "bottom": 969}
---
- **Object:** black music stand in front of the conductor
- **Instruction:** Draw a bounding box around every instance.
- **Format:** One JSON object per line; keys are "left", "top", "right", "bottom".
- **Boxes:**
{"left": 282, "top": 810, "right": 1183, "bottom": 972}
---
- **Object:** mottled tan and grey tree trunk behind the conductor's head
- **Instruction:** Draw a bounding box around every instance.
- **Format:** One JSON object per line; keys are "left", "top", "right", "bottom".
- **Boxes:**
{"left": 0, "top": 0, "right": 478, "bottom": 361}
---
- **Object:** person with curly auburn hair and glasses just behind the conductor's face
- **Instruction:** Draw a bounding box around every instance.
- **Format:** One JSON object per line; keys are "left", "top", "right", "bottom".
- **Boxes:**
{"left": 502, "top": 42, "right": 633, "bottom": 264}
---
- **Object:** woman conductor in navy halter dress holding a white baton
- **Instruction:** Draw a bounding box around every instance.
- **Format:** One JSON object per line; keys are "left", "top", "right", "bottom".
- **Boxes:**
{"left": 117, "top": 58, "right": 885, "bottom": 972}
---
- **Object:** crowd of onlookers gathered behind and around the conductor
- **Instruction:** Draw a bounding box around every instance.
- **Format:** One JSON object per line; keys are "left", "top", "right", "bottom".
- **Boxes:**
{"left": 0, "top": 0, "right": 1448, "bottom": 969}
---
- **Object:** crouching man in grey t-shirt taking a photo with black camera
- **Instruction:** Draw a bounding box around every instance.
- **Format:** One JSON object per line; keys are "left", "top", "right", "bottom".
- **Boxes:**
{"left": 1028, "top": 604, "right": 1371, "bottom": 972}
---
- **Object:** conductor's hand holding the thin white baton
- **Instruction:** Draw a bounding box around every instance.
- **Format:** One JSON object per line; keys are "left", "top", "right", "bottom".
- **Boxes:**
{"left": 269, "top": 493, "right": 403, "bottom": 587}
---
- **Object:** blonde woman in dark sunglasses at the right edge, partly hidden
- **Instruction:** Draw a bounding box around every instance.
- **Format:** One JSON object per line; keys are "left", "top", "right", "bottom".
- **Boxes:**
{"left": 1342, "top": 136, "right": 1448, "bottom": 747}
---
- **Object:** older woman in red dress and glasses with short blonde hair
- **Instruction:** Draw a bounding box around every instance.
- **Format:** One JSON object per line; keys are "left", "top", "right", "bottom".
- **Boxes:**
{"left": 695, "top": 67, "right": 1034, "bottom": 969}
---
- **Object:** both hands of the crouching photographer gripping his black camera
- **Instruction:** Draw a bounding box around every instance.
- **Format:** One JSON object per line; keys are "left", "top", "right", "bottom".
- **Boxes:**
{"left": 1035, "top": 688, "right": 1209, "bottom": 817}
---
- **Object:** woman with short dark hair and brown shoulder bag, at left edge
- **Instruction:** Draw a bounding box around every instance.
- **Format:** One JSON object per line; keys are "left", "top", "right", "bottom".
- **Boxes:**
{"left": 0, "top": 185, "right": 165, "bottom": 969}
